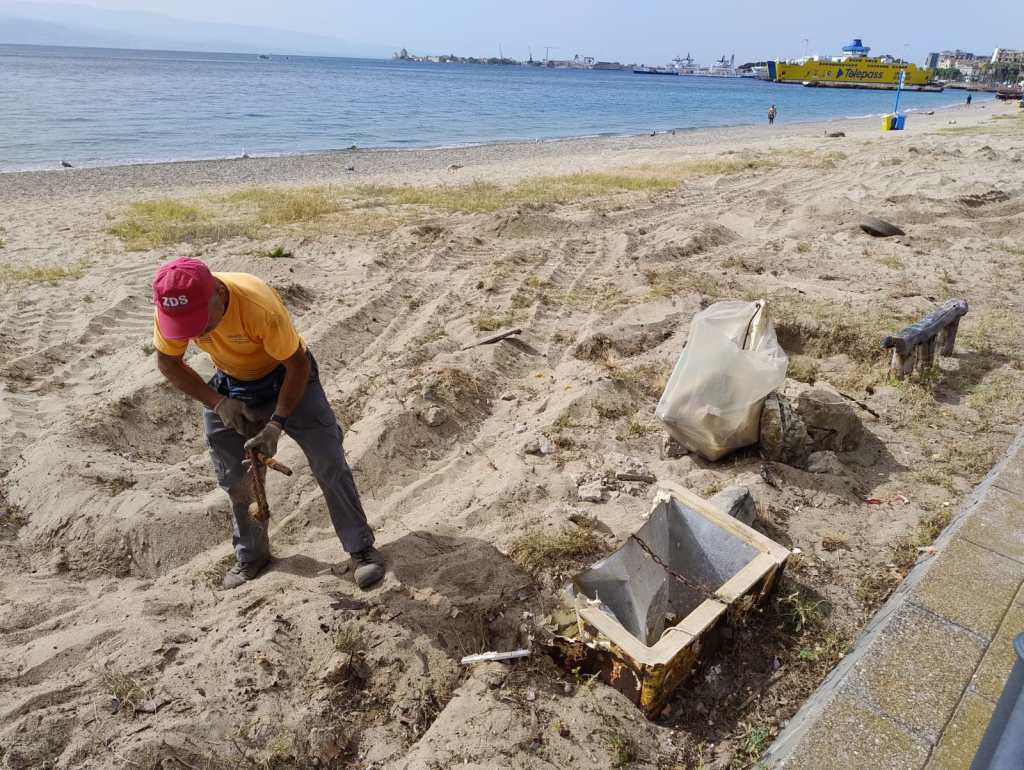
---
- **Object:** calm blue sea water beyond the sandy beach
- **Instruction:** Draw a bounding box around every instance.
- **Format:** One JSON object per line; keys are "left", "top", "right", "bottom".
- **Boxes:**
{"left": 0, "top": 45, "right": 963, "bottom": 171}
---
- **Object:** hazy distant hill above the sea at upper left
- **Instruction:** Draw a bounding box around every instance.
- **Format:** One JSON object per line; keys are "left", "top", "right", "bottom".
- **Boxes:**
{"left": 0, "top": 0, "right": 392, "bottom": 58}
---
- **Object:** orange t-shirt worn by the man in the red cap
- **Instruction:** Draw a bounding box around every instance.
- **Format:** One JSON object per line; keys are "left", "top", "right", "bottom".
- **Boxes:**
{"left": 153, "top": 272, "right": 302, "bottom": 380}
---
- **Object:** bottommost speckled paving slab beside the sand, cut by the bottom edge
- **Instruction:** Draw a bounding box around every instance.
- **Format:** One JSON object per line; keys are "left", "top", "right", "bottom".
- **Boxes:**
{"left": 781, "top": 692, "right": 928, "bottom": 770}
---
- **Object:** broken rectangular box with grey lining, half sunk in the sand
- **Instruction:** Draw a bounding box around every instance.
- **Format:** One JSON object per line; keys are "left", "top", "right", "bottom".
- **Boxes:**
{"left": 548, "top": 484, "right": 790, "bottom": 717}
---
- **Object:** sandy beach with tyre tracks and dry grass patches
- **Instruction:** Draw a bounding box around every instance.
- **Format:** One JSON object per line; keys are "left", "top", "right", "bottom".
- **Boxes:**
{"left": 0, "top": 101, "right": 1024, "bottom": 770}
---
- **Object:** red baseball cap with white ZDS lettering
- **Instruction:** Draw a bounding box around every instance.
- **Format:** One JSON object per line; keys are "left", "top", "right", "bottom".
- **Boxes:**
{"left": 153, "top": 257, "right": 217, "bottom": 340}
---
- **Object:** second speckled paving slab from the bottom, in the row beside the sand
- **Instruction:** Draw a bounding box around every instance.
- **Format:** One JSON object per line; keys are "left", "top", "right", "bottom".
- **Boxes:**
{"left": 849, "top": 604, "right": 986, "bottom": 741}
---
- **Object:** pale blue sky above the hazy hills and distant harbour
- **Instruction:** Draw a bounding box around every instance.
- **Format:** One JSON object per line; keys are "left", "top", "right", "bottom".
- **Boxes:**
{"left": 0, "top": 0, "right": 1024, "bottom": 63}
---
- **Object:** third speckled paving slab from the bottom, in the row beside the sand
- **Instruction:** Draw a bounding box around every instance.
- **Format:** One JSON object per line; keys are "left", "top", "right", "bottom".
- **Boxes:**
{"left": 910, "top": 537, "right": 1024, "bottom": 639}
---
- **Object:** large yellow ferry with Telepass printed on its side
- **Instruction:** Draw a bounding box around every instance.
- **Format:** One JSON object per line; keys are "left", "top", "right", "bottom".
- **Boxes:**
{"left": 768, "top": 38, "right": 942, "bottom": 91}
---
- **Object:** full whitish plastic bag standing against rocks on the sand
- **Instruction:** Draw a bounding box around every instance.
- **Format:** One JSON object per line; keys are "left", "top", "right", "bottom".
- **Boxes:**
{"left": 654, "top": 300, "right": 790, "bottom": 460}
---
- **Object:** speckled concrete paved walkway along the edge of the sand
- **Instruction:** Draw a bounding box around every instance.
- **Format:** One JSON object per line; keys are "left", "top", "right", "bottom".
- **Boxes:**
{"left": 763, "top": 433, "right": 1024, "bottom": 770}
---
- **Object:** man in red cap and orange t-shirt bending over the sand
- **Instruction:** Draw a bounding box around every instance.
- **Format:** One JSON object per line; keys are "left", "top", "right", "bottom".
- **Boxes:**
{"left": 153, "top": 257, "right": 384, "bottom": 589}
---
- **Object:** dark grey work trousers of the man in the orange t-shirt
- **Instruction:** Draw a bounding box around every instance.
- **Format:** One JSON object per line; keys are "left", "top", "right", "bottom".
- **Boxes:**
{"left": 203, "top": 364, "right": 374, "bottom": 564}
